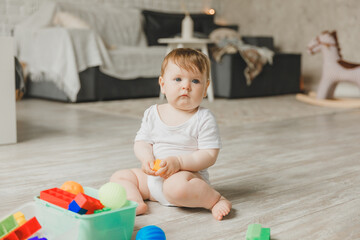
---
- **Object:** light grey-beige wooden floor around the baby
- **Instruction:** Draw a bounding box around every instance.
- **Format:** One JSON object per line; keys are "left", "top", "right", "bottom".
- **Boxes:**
{"left": 0, "top": 98, "right": 360, "bottom": 240}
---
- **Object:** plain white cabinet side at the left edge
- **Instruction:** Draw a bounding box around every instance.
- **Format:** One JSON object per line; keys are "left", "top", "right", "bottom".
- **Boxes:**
{"left": 0, "top": 37, "right": 16, "bottom": 144}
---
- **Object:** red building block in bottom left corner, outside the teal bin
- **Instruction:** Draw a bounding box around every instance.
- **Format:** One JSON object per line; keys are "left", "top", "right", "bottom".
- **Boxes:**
{"left": 0, "top": 217, "right": 41, "bottom": 240}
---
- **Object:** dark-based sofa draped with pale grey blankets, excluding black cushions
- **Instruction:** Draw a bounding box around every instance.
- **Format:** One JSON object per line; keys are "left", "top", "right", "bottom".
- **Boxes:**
{"left": 15, "top": 2, "right": 166, "bottom": 102}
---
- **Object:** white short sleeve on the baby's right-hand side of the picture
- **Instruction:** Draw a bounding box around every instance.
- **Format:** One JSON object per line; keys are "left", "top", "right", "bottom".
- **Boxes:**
{"left": 198, "top": 109, "right": 221, "bottom": 149}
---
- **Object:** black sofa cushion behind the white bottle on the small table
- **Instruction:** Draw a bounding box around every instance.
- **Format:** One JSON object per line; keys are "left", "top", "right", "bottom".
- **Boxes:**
{"left": 142, "top": 10, "right": 216, "bottom": 46}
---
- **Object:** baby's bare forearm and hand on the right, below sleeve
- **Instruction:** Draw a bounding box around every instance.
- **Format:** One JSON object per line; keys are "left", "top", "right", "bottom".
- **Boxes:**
{"left": 156, "top": 149, "right": 219, "bottom": 178}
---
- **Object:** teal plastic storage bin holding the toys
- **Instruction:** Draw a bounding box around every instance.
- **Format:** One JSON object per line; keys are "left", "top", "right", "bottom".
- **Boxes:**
{"left": 35, "top": 187, "right": 137, "bottom": 240}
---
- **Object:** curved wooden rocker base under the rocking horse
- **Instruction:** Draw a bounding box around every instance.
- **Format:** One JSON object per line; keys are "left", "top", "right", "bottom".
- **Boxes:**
{"left": 296, "top": 92, "right": 360, "bottom": 108}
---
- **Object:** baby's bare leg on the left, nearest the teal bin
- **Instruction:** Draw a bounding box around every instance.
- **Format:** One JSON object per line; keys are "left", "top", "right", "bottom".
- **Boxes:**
{"left": 110, "top": 169, "right": 150, "bottom": 215}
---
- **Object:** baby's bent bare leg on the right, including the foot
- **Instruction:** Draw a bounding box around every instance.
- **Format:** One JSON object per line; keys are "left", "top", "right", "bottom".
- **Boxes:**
{"left": 163, "top": 171, "right": 231, "bottom": 220}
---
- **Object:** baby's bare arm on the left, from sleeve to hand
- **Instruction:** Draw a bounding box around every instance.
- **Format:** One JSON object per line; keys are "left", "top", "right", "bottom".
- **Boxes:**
{"left": 134, "top": 141, "right": 155, "bottom": 175}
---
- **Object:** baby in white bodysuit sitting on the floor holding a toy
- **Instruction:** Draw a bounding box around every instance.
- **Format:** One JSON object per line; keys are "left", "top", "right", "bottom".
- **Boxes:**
{"left": 110, "top": 48, "right": 231, "bottom": 220}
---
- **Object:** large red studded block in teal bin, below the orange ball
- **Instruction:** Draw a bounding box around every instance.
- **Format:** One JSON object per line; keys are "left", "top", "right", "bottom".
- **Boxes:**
{"left": 40, "top": 188, "right": 76, "bottom": 209}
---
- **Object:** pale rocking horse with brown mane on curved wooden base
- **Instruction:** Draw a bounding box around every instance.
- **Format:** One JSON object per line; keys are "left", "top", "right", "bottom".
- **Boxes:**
{"left": 296, "top": 31, "right": 360, "bottom": 108}
